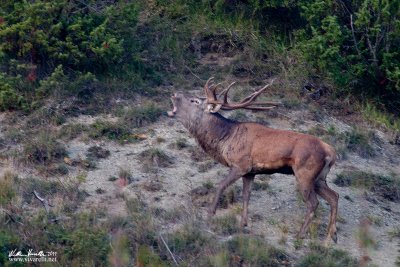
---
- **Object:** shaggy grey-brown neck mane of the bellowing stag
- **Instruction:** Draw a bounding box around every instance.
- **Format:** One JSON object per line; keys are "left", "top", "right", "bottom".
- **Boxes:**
{"left": 186, "top": 113, "right": 238, "bottom": 165}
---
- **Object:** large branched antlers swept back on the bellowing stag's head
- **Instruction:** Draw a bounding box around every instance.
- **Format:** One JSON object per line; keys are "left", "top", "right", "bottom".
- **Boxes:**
{"left": 204, "top": 77, "right": 281, "bottom": 113}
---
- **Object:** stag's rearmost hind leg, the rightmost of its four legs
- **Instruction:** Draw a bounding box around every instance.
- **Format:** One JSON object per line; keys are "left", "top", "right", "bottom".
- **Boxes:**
{"left": 315, "top": 180, "right": 339, "bottom": 243}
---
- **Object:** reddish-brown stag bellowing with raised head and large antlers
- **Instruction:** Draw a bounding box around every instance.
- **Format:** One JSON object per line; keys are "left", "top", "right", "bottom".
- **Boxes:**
{"left": 168, "top": 78, "right": 339, "bottom": 243}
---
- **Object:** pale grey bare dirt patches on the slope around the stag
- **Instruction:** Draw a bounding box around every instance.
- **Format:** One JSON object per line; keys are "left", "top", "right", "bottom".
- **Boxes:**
{"left": 52, "top": 105, "right": 400, "bottom": 266}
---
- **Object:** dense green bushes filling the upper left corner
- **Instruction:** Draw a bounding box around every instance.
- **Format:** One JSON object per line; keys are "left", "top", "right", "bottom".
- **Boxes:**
{"left": 0, "top": 0, "right": 138, "bottom": 110}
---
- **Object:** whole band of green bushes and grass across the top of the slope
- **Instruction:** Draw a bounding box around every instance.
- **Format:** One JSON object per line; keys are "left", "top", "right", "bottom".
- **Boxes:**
{"left": 0, "top": 0, "right": 400, "bottom": 127}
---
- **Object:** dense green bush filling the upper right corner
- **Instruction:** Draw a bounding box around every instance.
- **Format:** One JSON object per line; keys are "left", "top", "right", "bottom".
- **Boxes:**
{"left": 297, "top": 0, "right": 400, "bottom": 112}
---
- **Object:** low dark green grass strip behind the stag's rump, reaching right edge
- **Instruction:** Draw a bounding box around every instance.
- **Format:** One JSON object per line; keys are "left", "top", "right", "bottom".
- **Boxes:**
{"left": 333, "top": 170, "right": 400, "bottom": 202}
